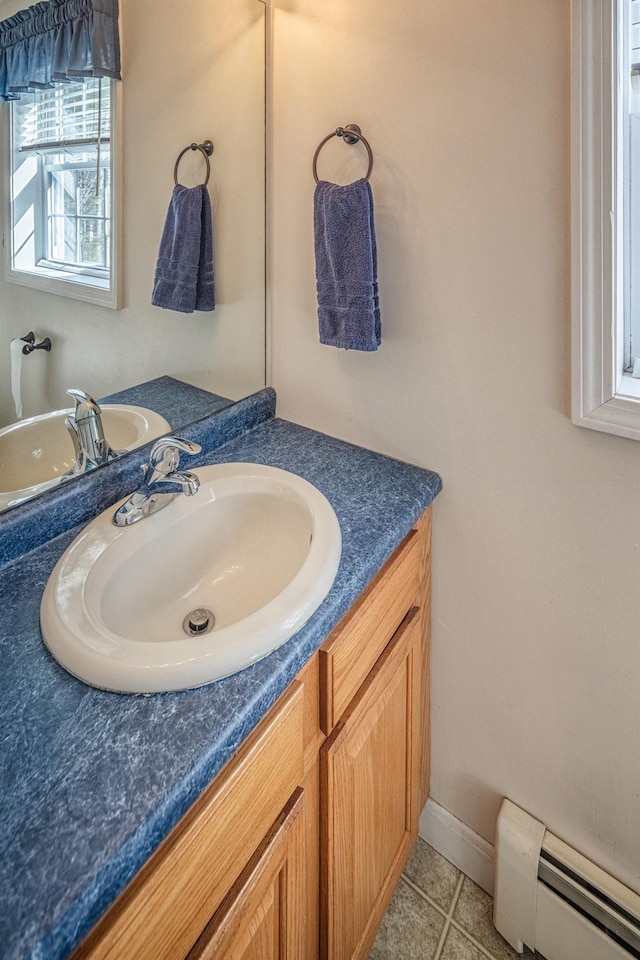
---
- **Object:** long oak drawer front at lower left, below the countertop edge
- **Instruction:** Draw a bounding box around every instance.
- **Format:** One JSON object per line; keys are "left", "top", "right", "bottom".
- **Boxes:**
{"left": 74, "top": 682, "right": 304, "bottom": 960}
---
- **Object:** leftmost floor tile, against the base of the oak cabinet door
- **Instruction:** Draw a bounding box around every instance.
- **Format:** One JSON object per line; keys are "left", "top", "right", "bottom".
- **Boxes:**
{"left": 369, "top": 880, "right": 445, "bottom": 960}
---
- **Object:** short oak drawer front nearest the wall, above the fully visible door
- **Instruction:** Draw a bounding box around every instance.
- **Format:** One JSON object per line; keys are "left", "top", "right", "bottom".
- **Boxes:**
{"left": 319, "top": 530, "right": 420, "bottom": 735}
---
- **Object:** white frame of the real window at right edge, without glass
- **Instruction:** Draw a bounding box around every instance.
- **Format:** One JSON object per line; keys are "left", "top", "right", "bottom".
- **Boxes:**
{"left": 571, "top": 0, "right": 640, "bottom": 440}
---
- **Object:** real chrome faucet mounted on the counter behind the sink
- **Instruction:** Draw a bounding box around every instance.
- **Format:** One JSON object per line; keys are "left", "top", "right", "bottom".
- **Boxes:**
{"left": 113, "top": 437, "right": 202, "bottom": 527}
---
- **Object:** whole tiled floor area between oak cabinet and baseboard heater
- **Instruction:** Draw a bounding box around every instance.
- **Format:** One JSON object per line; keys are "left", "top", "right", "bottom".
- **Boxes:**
{"left": 369, "top": 839, "right": 542, "bottom": 960}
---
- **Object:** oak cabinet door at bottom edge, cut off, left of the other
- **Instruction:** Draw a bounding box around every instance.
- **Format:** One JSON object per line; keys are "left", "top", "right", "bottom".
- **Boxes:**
{"left": 187, "top": 788, "right": 305, "bottom": 960}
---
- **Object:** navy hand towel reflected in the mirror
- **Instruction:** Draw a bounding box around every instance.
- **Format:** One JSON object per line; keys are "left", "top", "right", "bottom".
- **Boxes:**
{"left": 151, "top": 183, "right": 216, "bottom": 313}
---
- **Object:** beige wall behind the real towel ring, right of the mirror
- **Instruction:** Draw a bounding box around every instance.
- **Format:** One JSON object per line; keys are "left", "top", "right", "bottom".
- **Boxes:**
{"left": 271, "top": 0, "right": 640, "bottom": 891}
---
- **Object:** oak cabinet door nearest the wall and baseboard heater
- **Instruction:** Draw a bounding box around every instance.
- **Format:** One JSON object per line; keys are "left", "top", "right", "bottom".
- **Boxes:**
{"left": 320, "top": 608, "right": 421, "bottom": 960}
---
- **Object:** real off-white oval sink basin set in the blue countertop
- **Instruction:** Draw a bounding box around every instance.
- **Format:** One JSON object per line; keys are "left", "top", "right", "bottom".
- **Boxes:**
{"left": 40, "top": 463, "right": 341, "bottom": 693}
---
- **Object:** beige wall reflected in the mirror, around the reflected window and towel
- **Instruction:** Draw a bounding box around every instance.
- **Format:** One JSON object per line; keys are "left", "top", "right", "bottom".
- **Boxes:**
{"left": 0, "top": 0, "right": 265, "bottom": 508}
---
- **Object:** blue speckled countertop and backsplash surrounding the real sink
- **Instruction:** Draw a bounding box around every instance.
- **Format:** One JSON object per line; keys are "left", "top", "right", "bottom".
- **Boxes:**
{"left": 0, "top": 391, "right": 441, "bottom": 960}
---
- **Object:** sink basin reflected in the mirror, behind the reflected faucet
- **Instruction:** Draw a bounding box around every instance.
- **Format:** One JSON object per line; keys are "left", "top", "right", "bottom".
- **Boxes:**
{"left": 0, "top": 403, "right": 171, "bottom": 509}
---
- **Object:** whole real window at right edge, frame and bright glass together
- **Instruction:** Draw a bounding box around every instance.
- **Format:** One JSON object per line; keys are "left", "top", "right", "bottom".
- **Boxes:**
{"left": 571, "top": 0, "right": 640, "bottom": 440}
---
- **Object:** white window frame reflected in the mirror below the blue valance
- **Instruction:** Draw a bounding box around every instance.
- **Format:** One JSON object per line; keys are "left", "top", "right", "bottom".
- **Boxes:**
{"left": 2, "top": 83, "right": 122, "bottom": 310}
